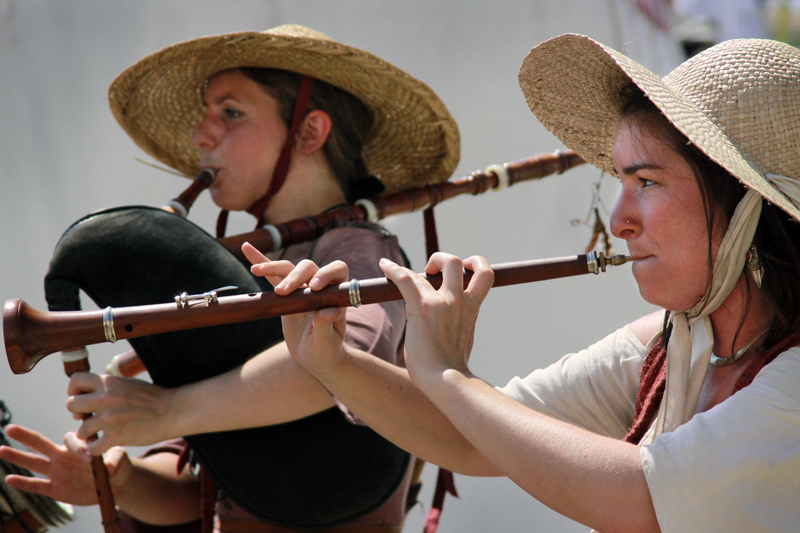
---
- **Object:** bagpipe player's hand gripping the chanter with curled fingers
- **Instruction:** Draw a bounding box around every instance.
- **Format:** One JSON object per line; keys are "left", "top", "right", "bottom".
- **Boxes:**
{"left": 67, "top": 372, "right": 173, "bottom": 455}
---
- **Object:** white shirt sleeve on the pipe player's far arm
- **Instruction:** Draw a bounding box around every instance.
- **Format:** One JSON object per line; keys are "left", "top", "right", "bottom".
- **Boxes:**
{"left": 498, "top": 326, "right": 649, "bottom": 439}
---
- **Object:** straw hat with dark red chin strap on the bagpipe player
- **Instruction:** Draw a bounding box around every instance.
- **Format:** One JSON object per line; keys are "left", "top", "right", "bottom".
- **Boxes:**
{"left": 108, "top": 25, "right": 461, "bottom": 192}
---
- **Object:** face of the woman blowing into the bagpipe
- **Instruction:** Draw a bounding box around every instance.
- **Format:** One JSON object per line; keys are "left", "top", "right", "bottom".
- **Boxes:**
{"left": 193, "top": 70, "right": 288, "bottom": 211}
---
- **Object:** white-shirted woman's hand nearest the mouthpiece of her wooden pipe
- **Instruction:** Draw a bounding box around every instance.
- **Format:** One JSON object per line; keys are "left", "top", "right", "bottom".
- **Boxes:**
{"left": 380, "top": 253, "right": 494, "bottom": 386}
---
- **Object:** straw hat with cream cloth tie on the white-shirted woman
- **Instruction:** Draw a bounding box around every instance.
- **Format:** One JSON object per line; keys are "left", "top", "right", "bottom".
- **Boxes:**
{"left": 519, "top": 35, "right": 800, "bottom": 220}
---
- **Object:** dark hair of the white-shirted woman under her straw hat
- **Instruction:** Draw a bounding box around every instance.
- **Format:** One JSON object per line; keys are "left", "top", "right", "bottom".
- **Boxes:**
{"left": 620, "top": 83, "right": 800, "bottom": 355}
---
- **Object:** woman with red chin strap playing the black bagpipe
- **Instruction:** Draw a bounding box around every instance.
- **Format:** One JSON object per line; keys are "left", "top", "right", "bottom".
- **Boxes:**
{"left": 0, "top": 25, "right": 459, "bottom": 532}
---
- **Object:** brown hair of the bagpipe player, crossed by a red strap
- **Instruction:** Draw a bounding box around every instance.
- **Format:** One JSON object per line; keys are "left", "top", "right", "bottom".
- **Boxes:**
{"left": 240, "top": 67, "right": 384, "bottom": 202}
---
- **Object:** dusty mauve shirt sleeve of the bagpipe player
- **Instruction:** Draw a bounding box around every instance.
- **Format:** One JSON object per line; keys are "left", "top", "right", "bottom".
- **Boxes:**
{"left": 312, "top": 226, "right": 406, "bottom": 424}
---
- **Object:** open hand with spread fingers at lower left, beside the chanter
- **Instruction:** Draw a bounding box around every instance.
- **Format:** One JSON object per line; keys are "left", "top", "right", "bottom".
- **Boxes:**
{"left": 0, "top": 424, "right": 132, "bottom": 505}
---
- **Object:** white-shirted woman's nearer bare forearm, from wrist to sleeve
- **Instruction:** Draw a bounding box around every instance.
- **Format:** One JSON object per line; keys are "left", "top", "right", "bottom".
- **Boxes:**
{"left": 420, "top": 369, "right": 658, "bottom": 531}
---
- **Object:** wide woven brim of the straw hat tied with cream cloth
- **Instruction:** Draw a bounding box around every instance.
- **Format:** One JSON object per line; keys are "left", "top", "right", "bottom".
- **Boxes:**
{"left": 519, "top": 34, "right": 800, "bottom": 220}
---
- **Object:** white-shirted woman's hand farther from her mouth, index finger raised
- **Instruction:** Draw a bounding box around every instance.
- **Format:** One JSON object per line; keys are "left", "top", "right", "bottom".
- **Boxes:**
{"left": 242, "top": 243, "right": 349, "bottom": 375}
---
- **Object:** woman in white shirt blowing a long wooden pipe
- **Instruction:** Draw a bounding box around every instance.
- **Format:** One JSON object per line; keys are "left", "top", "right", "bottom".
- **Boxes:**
{"left": 64, "top": 35, "right": 800, "bottom": 532}
